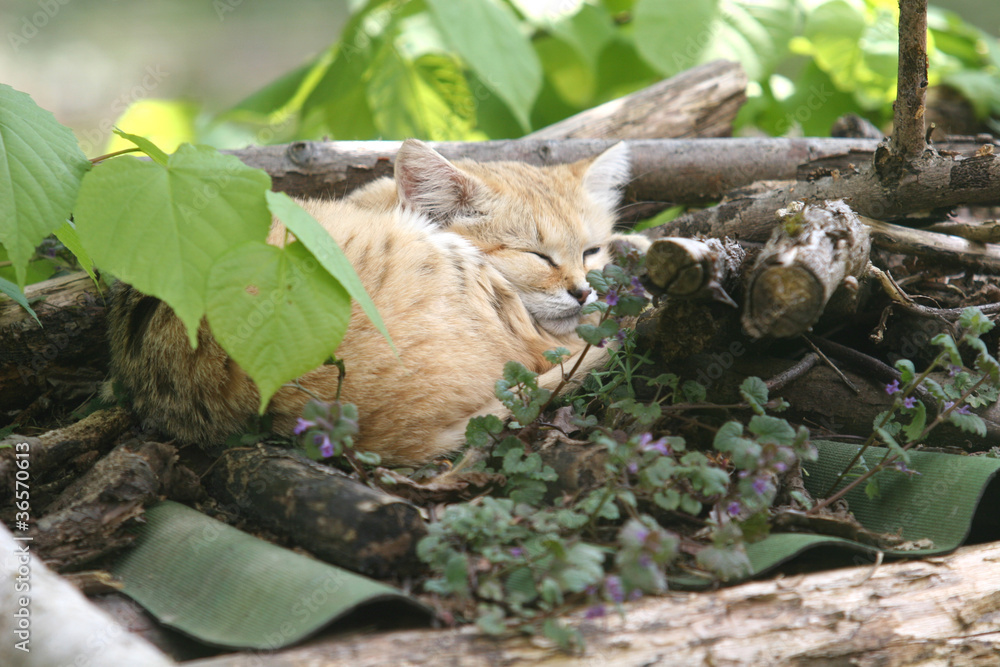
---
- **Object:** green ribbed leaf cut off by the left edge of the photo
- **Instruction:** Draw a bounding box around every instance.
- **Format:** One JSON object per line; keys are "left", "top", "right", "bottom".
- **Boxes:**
{"left": 0, "top": 84, "right": 91, "bottom": 287}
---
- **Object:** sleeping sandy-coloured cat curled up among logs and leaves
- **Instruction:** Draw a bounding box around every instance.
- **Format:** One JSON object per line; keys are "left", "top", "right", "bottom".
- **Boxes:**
{"left": 108, "top": 140, "right": 629, "bottom": 464}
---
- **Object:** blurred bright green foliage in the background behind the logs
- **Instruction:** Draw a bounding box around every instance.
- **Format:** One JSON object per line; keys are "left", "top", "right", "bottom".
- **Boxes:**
{"left": 97, "top": 0, "right": 1000, "bottom": 154}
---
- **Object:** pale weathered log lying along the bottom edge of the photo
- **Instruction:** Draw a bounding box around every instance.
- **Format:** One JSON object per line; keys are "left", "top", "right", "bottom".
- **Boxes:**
{"left": 187, "top": 543, "right": 1000, "bottom": 667}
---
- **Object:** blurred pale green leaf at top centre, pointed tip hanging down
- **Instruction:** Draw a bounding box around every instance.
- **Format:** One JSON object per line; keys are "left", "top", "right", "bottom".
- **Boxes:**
{"left": 427, "top": 0, "right": 542, "bottom": 132}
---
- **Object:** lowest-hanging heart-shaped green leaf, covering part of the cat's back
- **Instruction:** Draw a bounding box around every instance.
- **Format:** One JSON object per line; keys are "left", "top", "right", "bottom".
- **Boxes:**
{"left": 206, "top": 241, "right": 351, "bottom": 413}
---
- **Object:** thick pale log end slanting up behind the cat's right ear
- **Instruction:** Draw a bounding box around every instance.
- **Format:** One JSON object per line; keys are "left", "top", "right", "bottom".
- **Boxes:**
{"left": 527, "top": 60, "right": 747, "bottom": 139}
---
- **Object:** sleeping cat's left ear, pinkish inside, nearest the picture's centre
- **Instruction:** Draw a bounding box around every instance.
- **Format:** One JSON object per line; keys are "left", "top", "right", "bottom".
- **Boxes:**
{"left": 394, "top": 139, "right": 483, "bottom": 222}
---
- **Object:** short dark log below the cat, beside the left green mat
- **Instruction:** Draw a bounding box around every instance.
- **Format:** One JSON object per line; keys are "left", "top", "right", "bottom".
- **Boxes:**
{"left": 208, "top": 445, "right": 427, "bottom": 578}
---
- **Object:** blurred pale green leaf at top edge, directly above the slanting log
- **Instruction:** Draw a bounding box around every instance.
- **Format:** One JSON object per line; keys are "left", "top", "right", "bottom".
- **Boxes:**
{"left": 633, "top": 0, "right": 719, "bottom": 76}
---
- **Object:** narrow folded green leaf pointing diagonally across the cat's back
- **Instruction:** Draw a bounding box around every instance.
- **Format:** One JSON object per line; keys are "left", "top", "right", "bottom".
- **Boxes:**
{"left": 265, "top": 191, "right": 396, "bottom": 352}
